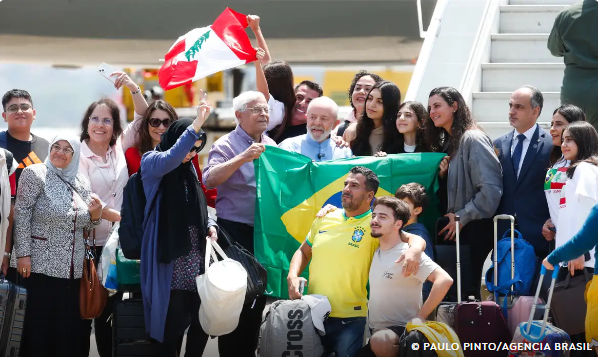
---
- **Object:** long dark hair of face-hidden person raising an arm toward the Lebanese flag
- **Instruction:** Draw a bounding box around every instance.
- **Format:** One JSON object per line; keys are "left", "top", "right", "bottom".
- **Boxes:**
{"left": 264, "top": 61, "right": 297, "bottom": 140}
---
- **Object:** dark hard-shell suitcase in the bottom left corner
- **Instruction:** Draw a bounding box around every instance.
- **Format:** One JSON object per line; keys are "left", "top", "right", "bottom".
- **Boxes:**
{"left": 0, "top": 276, "right": 27, "bottom": 357}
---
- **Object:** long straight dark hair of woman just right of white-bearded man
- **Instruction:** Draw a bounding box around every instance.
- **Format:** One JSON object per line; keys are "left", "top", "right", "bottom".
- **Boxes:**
{"left": 351, "top": 81, "right": 401, "bottom": 156}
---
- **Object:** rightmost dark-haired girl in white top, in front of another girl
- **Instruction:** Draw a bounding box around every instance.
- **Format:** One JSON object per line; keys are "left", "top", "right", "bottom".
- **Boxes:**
{"left": 556, "top": 121, "right": 598, "bottom": 275}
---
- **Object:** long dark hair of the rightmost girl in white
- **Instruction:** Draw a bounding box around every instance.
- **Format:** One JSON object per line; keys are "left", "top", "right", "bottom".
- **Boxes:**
{"left": 563, "top": 121, "right": 598, "bottom": 178}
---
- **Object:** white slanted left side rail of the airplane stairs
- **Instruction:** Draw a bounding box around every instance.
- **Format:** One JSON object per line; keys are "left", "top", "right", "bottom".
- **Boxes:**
{"left": 405, "top": 0, "right": 449, "bottom": 101}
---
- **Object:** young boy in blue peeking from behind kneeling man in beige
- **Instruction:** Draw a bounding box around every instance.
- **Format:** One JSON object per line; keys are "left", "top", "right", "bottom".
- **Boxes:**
{"left": 395, "top": 182, "right": 434, "bottom": 301}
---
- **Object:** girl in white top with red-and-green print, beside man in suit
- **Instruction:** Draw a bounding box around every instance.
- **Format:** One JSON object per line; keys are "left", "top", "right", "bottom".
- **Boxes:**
{"left": 542, "top": 104, "right": 586, "bottom": 241}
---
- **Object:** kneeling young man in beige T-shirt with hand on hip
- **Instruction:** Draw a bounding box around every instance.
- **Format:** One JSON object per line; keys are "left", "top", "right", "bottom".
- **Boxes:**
{"left": 358, "top": 197, "right": 453, "bottom": 357}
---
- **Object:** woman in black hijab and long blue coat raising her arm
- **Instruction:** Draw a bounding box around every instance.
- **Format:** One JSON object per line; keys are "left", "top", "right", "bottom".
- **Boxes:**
{"left": 141, "top": 91, "right": 217, "bottom": 357}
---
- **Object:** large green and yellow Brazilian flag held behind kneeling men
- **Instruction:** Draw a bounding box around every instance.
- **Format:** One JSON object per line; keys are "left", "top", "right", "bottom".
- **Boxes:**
{"left": 254, "top": 146, "right": 445, "bottom": 299}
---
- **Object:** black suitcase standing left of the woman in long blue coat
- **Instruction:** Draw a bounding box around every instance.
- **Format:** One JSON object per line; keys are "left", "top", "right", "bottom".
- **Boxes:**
{"left": 112, "top": 299, "right": 160, "bottom": 357}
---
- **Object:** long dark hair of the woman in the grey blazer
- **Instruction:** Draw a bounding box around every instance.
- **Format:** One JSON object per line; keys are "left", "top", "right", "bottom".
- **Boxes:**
{"left": 425, "top": 87, "right": 479, "bottom": 157}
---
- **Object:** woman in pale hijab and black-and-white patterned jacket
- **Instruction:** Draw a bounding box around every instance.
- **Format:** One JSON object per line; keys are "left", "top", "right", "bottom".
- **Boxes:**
{"left": 11, "top": 136, "right": 102, "bottom": 357}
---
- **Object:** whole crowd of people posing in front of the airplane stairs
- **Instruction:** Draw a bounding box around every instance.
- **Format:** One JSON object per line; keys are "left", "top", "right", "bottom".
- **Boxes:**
{"left": 0, "top": 9, "right": 598, "bottom": 357}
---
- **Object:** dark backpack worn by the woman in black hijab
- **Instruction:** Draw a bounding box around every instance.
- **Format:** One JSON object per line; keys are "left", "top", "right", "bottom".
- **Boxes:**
{"left": 118, "top": 168, "right": 158, "bottom": 259}
